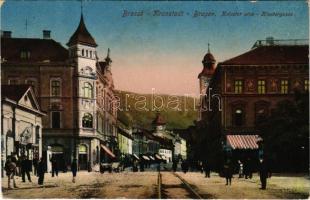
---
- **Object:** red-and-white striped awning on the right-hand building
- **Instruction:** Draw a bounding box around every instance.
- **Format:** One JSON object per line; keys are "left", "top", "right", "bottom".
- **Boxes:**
{"left": 226, "top": 135, "right": 262, "bottom": 149}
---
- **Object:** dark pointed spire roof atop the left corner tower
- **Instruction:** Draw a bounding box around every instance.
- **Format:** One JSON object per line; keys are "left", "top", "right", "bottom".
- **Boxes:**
{"left": 67, "top": 14, "right": 98, "bottom": 47}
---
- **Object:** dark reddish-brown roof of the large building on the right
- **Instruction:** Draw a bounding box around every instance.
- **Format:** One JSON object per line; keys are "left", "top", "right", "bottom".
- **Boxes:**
{"left": 220, "top": 45, "right": 309, "bottom": 65}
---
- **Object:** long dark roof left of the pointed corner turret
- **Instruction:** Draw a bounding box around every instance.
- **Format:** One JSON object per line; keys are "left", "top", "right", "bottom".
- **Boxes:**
{"left": 1, "top": 38, "right": 69, "bottom": 62}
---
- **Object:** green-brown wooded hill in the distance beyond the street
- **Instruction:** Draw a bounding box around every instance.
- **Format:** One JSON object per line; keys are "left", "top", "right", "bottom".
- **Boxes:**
{"left": 116, "top": 91, "right": 198, "bottom": 129}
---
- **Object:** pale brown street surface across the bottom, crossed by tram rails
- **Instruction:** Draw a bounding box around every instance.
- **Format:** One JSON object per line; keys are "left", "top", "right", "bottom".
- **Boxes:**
{"left": 2, "top": 172, "right": 310, "bottom": 199}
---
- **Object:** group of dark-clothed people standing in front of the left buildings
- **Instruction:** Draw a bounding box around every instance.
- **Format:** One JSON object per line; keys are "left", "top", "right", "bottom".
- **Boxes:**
{"left": 4, "top": 155, "right": 78, "bottom": 189}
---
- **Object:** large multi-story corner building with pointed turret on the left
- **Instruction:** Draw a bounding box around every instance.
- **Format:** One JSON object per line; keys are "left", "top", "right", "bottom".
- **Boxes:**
{"left": 1, "top": 15, "right": 117, "bottom": 169}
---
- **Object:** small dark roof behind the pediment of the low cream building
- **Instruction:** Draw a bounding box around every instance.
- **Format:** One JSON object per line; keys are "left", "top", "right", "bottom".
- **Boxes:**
{"left": 1, "top": 85, "right": 30, "bottom": 102}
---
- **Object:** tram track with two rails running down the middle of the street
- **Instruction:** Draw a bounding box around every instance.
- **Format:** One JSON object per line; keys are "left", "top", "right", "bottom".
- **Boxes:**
{"left": 158, "top": 172, "right": 203, "bottom": 199}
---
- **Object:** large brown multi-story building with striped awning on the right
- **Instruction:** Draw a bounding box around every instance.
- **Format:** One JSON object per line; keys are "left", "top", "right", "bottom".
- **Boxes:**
{"left": 202, "top": 38, "right": 309, "bottom": 159}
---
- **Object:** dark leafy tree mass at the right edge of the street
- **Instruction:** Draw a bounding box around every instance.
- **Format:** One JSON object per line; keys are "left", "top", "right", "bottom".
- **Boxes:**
{"left": 258, "top": 92, "right": 309, "bottom": 172}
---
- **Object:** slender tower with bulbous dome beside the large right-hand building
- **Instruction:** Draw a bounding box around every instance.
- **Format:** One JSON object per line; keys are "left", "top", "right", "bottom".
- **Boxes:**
{"left": 198, "top": 44, "right": 216, "bottom": 121}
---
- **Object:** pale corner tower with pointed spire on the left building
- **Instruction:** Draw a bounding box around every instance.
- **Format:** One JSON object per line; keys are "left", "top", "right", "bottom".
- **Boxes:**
{"left": 67, "top": 14, "right": 97, "bottom": 164}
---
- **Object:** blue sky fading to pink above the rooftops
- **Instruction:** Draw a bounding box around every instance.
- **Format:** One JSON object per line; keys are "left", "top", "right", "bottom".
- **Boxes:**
{"left": 1, "top": 0, "right": 309, "bottom": 96}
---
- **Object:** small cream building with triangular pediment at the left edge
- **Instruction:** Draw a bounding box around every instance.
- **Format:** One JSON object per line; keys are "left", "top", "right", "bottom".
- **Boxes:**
{"left": 1, "top": 85, "right": 45, "bottom": 169}
